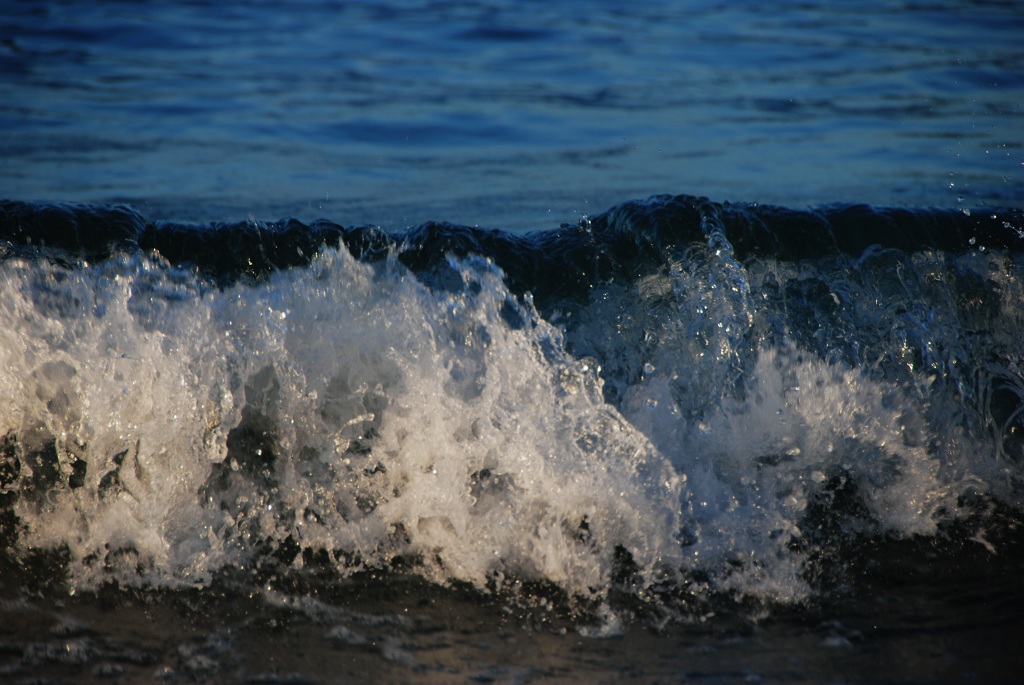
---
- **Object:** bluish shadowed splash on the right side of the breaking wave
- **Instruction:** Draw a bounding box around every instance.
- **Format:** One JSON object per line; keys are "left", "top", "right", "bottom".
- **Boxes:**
{"left": 566, "top": 240, "right": 1024, "bottom": 601}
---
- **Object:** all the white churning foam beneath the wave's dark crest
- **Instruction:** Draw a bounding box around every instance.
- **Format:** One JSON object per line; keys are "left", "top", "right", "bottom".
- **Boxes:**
{"left": 0, "top": 244, "right": 1019, "bottom": 601}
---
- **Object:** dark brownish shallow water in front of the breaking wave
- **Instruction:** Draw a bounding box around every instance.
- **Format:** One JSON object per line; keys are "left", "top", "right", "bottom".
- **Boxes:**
{"left": 0, "top": 528, "right": 1024, "bottom": 684}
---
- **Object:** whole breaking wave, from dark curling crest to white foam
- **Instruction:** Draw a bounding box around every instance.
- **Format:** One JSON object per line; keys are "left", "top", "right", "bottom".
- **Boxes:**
{"left": 0, "top": 197, "right": 1024, "bottom": 615}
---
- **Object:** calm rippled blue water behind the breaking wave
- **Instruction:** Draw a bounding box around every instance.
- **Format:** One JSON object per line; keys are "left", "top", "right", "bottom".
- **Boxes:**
{"left": 0, "top": 0, "right": 1024, "bottom": 229}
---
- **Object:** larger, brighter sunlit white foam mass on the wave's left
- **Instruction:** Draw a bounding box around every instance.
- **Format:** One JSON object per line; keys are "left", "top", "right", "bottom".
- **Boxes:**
{"left": 0, "top": 252, "right": 679, "bottom": 594}
